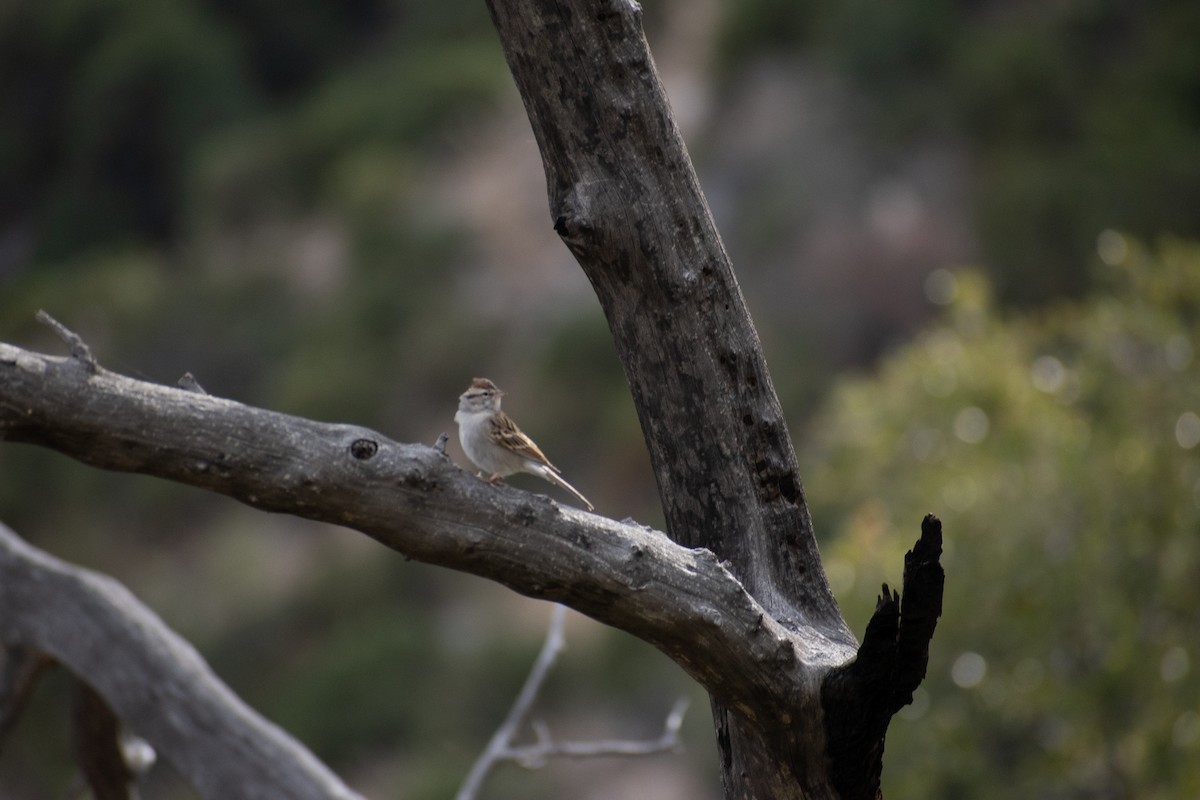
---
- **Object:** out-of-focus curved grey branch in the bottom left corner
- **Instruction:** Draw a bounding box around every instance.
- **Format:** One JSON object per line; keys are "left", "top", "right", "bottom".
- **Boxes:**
{"left": 0, "top": 524, "right": 359, "bottom": 800}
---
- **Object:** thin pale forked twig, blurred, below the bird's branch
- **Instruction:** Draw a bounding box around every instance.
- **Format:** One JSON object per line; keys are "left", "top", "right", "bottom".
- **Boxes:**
{"left": 455, "top": 606, "right": 689, "bottom": 800}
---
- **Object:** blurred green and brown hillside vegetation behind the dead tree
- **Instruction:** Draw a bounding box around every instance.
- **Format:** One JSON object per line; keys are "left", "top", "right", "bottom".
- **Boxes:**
{"left": 0, "top": 0, "right": 1200, "bottom": 799}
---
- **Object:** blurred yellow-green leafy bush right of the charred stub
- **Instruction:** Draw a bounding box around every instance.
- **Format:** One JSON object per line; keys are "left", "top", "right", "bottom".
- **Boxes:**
{"left": 799, "top": 231, "right": 1200, "bottom": 800}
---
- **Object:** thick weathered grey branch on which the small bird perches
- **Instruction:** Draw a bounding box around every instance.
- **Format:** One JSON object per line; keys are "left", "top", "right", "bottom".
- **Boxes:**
{"left": 0, "top": 344, "right": 835, "bottom": 718}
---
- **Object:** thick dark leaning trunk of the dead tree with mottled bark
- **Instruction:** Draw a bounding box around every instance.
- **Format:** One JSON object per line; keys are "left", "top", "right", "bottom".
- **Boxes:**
{"left": 488, "top": 0, "right": 940, "bottom": 799}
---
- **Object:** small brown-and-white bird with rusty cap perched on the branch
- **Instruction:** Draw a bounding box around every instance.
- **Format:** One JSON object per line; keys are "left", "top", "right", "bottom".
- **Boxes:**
{"left": 454, "top": 378, "right": 595, "bottom": 511}
